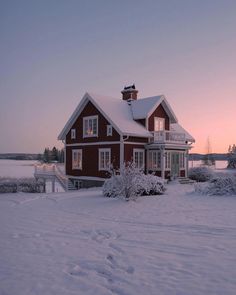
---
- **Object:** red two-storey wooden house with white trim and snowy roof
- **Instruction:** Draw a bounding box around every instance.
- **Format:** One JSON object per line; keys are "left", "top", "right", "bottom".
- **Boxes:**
{"left": 58, "top": 85, "right": 194, "bottom": 187}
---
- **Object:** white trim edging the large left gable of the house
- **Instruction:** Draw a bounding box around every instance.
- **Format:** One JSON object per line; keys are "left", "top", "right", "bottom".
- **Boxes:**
{"left": 58, "top": 92, "right": 122, "bottom": 140}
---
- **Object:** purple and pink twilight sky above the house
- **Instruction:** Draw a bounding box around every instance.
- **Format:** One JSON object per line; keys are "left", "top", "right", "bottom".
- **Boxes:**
{"left": 0, "top": 0, "right": 236, "bottom": 153}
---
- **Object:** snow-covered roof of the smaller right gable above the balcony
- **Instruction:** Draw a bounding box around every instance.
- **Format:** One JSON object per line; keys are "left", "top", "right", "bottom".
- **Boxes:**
{"left": 131, "top": 95, "right": 178, "bottom": 123}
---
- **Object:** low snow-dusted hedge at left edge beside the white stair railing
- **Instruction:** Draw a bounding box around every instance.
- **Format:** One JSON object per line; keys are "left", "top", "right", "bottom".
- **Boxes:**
{"left": 0, "top": 178, "right": 44, "bottom": 193}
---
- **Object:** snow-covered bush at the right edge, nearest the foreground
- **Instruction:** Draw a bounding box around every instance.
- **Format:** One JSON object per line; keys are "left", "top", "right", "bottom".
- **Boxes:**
{"left": 195, "top": 174, "right": 236, "bottom": 196}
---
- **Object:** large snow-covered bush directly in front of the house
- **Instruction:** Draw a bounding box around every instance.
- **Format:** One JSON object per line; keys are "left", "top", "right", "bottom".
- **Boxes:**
{"left": 103, "top": 163, "right": 166, "bottom": 200}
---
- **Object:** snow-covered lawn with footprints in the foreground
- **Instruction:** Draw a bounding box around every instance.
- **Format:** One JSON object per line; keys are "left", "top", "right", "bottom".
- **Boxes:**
{"left": 0, "top": 184, "right": 236, "bottom": 295}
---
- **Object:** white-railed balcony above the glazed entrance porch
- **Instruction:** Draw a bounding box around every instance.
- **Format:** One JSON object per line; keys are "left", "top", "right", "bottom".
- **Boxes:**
{"left": 151, "top": 130, "right": 186, "bottom": 144}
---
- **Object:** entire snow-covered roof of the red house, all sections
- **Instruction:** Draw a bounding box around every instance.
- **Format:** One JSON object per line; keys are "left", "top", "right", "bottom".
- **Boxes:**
{"left": 58, "top": 93, "right": 195, "bottom": 142}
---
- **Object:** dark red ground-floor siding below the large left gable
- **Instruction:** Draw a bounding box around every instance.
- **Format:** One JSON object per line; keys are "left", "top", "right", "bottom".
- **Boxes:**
{"left": 66, "top": 144, "right": 120, "bottom": 178}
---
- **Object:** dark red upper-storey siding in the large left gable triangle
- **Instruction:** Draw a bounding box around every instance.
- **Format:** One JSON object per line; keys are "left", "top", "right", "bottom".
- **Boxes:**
{"left": 66, "top": 102, "right": 120, "bottom": 144}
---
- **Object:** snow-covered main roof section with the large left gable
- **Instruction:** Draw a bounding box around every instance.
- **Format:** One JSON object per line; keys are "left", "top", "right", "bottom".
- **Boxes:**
{"left": 58, "top": 93, "right": 152, "bottom": 140}
